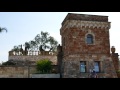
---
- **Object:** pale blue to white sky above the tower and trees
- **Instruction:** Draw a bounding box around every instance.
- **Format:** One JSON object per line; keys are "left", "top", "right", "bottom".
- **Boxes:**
{"left": 0, "top": 12, "right": 120, "bottom": 63}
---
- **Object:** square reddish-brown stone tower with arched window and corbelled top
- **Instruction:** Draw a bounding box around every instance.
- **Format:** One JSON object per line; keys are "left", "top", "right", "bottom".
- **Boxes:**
{"left": 60, "top": 13, "right": 117, "bottom": 78}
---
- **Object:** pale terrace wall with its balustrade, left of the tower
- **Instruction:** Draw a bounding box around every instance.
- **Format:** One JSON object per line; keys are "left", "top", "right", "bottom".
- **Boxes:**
{"left": 8, "top": 51, "right": 57, "bottom": 65}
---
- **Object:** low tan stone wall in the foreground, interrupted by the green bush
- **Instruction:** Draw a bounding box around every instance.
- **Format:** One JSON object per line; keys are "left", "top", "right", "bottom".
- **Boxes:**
{"left": 0, "top": 65, "right": 58, "bottom": 78}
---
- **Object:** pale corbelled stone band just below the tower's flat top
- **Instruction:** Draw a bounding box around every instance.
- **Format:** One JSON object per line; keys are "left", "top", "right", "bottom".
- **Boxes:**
{"left": 60, "top": 20, "right": 111, "bottom": 34}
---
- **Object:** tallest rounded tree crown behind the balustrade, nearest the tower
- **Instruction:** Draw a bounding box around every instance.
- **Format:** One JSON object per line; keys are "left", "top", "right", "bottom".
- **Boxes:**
{"left": 35, "top": 31, "right": 58, "bottom": 51}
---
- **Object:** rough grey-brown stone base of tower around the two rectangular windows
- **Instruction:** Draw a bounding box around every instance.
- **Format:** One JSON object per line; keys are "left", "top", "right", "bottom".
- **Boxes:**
{"left": 62, "top": 54, "right": 117, "bottom": 78}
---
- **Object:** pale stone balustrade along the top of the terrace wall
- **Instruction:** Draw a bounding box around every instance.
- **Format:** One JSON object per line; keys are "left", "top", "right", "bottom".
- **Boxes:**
{"left": 9, "top": 51, "right": 55, "bottom": 56}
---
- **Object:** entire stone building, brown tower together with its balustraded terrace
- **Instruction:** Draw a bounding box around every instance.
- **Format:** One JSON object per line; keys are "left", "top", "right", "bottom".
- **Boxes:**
{"left": 9, "top": 13, "right": 120, "bottom": 78}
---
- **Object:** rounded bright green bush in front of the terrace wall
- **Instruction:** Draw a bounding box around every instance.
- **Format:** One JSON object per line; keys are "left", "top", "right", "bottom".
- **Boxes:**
{"left": 36, "top": 59, "right": 52, "bottom": 73}
